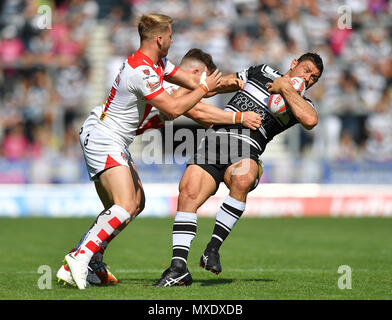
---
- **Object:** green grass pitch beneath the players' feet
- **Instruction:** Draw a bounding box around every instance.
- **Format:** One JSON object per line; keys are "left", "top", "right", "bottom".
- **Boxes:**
{"left": 0, "top": 218, "right": 392, "bottom": 300}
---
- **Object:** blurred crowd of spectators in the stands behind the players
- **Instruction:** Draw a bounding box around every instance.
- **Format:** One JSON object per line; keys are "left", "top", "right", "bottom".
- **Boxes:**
{"left": 0, "top": 0, "right": 392, "bottom": 182}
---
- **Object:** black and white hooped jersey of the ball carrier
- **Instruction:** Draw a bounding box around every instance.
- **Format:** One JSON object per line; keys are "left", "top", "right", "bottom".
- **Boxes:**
{"left": 220, "top": 64, "right": 314, "bottom": 153}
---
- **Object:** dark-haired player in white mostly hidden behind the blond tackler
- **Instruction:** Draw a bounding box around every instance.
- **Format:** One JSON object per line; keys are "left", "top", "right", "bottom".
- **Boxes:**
{"left": 57, "top": 43, "right": 261, "bottom": 285}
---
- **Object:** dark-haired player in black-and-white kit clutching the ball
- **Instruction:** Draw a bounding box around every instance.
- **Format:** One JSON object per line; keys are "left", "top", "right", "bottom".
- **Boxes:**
{"left": 154, "top": 53, "right": 324, "bottom": 287}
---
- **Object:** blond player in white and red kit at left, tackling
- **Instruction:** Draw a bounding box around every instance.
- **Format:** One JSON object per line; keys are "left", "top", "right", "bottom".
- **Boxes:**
{"left": 57, "top": 14, "right": 240, "bottom": 289}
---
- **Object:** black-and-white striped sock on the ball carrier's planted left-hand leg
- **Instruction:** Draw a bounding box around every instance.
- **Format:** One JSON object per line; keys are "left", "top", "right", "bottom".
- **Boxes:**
{"left": 172, "top": 211, "right": 197, "bottom": 264}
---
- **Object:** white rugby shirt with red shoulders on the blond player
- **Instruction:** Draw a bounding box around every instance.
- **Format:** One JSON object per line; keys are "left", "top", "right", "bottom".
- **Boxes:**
{"left": 97, "top": 50, "right": 178, "bottom": 145}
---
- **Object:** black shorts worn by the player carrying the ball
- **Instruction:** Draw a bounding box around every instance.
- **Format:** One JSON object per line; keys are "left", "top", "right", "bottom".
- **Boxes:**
{"left": 188, "top": 125, "right": 265, "bottom": 194}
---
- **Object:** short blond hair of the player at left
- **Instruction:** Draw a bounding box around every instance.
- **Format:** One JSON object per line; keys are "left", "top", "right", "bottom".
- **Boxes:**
{"left": 138, "top": 13, "right": 173, "bottom": 41}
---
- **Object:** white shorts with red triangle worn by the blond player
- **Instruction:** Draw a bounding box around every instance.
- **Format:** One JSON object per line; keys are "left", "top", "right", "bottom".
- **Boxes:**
{"left": 79, "top": 115, "right": 133, "bottom": 181}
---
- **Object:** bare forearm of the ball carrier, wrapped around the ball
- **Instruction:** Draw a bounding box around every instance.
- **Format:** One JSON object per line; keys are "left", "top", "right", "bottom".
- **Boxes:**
{"left": 281, "top": 86, "right": 318, "bottom": 130}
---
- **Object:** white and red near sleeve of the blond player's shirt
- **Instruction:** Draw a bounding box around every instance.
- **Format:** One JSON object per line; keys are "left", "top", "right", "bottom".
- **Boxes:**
{"left": 128, "top": 66, "right": 164, "bottom": 100}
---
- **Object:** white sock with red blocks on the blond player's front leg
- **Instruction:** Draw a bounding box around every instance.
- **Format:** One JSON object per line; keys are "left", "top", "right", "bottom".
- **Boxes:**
{"left": 72, "top": 205, "right": 130, "bottom": 265}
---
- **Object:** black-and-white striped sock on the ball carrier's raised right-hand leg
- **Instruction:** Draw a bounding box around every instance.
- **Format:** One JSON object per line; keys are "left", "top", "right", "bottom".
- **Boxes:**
{"left": 207, "top": 196, "right": 246, "bottom": 250}
